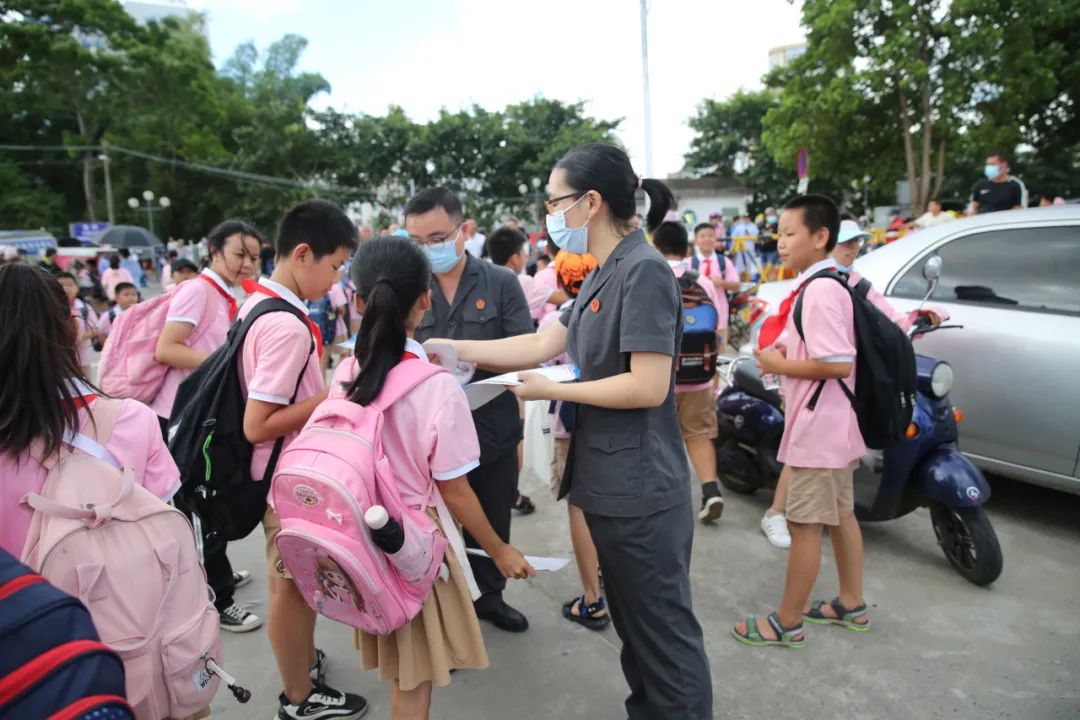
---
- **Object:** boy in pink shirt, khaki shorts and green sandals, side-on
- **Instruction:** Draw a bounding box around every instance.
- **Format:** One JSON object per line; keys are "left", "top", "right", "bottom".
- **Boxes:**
{"left": 732, "top": 194, "right": 870, "bottom": 648}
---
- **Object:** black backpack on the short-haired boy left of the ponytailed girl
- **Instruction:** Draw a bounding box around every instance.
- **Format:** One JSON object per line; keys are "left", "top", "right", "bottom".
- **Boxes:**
{"left": 168, "top": 298, "right": 315, "bottom": 541}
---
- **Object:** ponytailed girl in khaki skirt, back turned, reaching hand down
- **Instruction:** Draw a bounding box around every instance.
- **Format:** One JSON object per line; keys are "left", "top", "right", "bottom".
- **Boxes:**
{"left": 330, "top": 237, "right": 535, "bottom": 718}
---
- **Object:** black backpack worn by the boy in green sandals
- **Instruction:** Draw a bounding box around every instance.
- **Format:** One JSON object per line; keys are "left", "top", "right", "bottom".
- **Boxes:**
{"left": 794, "top": 269, "right": 916, "bottom": 450}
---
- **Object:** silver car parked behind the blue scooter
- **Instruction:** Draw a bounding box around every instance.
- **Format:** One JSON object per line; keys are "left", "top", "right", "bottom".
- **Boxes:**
{"left": 752, "top": 205, "right": 1080, "bottom": 494}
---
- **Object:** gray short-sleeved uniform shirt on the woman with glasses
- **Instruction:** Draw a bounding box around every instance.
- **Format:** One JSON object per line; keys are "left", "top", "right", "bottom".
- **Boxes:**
{"left": 562, "top": 230, "right": 690, "bottom": 517}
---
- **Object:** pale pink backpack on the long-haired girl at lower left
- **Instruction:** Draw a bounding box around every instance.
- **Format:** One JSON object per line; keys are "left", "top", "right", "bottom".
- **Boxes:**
{"left": 22, "top": 398, "right": 221, "bottom": 720}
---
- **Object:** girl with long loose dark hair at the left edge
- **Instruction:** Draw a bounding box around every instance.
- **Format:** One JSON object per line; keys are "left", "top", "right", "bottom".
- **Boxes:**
{"left": 0, "top": 263, "right": 180, "bottom": 557}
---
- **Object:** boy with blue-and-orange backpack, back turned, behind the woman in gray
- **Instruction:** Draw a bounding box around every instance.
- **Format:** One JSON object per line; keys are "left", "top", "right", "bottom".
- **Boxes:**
{"left": 652, "top": 222, "right": 730, "bottom": 522}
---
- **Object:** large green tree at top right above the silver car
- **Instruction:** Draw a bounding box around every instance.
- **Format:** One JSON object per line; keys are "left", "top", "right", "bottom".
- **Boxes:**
{"left": 764, "top": 0, "right": 1080, "bottom": 209}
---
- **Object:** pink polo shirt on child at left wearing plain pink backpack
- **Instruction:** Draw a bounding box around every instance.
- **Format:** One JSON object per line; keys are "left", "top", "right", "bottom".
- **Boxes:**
{"left": 150, "top": 268, "right": 232, "bottom": 418}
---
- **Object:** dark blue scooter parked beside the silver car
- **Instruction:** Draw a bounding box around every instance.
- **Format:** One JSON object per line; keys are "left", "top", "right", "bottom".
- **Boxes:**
{"left": 716, "top": 260, "right": 1002, "bottom": 585}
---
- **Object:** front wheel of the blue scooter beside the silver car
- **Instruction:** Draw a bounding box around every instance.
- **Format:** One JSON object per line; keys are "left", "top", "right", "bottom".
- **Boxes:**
{"left": 930, "top": 503, "right": 1003, "bottom": 586}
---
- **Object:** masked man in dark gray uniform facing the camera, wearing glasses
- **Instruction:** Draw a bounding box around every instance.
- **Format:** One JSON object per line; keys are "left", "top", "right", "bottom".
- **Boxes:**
{"left": 405, "top": 188, "right": 532, "bottom": 633}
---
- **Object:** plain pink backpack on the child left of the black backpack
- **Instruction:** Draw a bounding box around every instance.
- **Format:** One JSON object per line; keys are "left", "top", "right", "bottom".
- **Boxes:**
{"left": 98, "top": 280, "right": 217, "bottom": 403}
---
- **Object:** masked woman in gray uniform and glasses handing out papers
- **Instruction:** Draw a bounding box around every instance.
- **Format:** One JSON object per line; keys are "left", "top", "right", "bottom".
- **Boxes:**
{"left": 434, "top": 144, "right": 713, "bottom": 720}
